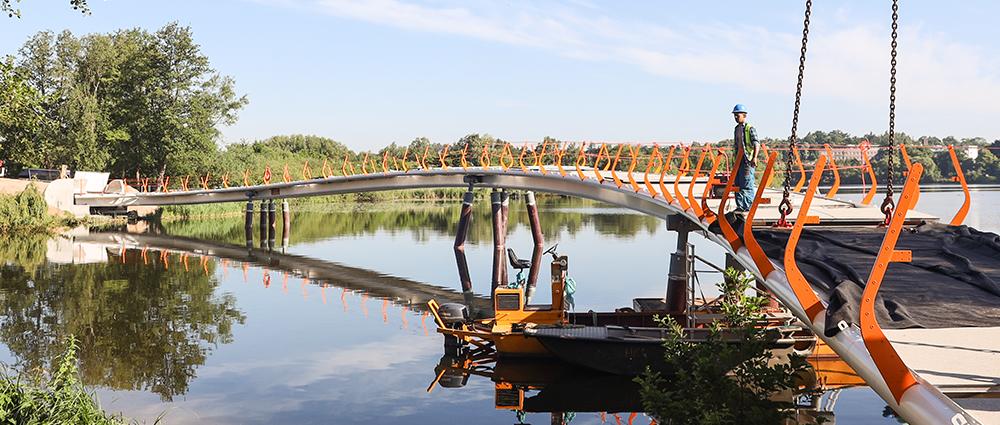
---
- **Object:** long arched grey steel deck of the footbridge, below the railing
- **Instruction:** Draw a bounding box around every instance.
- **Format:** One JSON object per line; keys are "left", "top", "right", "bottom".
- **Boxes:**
{"left": 75, "top": 164, "right": 980, "bottom": 424}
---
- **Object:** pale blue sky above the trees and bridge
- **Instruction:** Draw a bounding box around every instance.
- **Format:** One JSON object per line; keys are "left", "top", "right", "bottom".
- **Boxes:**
{"left": 0, "top": 0, "right": 1000, "bottom": 148}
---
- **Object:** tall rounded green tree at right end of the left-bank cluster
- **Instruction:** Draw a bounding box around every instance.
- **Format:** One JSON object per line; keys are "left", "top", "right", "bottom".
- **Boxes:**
{"left": 109, "top": 22, "right": 247, "bottom": 177}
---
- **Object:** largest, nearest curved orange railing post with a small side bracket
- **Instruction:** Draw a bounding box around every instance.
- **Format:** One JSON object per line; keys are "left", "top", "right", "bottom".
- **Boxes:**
{"left": 859, "top": 163, "right": 924, "bottom": 403}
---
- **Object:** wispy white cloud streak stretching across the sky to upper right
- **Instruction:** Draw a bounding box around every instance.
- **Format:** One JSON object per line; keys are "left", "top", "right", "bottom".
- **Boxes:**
{"left": 242, "top": 0, "right": 1000, "bottom": 139}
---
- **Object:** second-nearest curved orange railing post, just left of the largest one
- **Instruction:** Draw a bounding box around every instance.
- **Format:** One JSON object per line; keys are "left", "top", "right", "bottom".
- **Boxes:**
{"left": 784, "top": 155, "right": 826, "bottom": 322}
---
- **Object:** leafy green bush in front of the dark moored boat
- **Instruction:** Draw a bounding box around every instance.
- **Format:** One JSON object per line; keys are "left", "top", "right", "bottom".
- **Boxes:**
{"left": 636, "top": 268, "right": 808, "bottom": 425}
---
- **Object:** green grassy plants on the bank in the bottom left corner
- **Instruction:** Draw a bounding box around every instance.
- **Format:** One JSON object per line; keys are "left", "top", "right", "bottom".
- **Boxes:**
{"left": 0, "top": 336, "right": 127, "bottom": 424}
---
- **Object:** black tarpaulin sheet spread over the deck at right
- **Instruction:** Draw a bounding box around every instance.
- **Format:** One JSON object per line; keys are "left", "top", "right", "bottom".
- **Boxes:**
{"left": 736, "top": 223, "right": 1000, "bottom": 336}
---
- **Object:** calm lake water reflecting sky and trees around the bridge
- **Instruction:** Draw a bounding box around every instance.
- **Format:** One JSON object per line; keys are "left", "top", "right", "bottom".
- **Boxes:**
{"left": 0, "top": 190, "right": 1000, "bottom": 425}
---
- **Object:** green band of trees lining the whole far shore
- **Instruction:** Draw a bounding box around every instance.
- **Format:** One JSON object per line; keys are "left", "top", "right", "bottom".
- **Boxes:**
{"left": 0, "top": 23, "right": 1000, "bottom": 187}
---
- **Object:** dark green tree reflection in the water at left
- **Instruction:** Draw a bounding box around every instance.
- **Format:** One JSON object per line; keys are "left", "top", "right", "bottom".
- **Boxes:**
{"left": 0, "top": 237, "right": 246, "bottom": 401}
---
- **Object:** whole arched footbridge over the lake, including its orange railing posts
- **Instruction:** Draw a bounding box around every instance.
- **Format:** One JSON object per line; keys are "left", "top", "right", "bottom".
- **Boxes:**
{"left": 75, "top": 145, "right": 1000, "bottom": 424}
